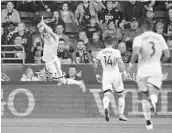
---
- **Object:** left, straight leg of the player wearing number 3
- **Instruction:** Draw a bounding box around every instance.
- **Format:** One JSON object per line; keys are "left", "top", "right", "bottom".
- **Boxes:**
{"left": 137, "top": 77, "right": 153, "bottom": 130}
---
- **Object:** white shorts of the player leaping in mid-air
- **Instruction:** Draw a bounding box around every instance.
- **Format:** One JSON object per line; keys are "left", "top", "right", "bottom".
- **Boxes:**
{"left": 45, "top": 57, "right": 63, "bottom": 78}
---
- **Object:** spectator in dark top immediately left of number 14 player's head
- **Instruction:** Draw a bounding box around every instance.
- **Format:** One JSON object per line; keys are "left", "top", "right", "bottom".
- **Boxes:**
{"left": 89, "top": 32, "right": 105, "bottom": 61}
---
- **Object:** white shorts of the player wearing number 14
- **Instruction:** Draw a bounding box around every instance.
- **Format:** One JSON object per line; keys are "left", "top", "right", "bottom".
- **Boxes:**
{"left": 102, "top": 74, "right": 124, "bottom": 93}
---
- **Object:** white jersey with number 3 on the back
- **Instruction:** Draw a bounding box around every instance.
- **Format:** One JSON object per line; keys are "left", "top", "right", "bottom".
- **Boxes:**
{"left": 133, "top": 31, "right": 168, "bottom": 76}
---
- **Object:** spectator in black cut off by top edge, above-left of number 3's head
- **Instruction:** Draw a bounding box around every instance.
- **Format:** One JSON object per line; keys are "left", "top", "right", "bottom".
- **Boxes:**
{"left": 121, "top": 0, "right": 145, "bottom": 27}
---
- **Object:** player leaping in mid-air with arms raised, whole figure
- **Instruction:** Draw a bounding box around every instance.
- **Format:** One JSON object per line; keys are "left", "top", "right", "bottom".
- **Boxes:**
{"left": 38, "top": 18, "right": 86, "bottom": 92}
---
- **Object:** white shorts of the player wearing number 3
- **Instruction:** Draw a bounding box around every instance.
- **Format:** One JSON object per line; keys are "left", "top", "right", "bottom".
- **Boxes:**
{"left": 137, "top": 75, "right": 162, "bottom": 92}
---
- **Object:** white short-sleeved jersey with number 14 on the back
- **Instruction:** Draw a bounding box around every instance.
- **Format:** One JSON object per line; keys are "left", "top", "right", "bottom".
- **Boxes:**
{"left": 96, "top": 47, "right": 121, "bottom": 77}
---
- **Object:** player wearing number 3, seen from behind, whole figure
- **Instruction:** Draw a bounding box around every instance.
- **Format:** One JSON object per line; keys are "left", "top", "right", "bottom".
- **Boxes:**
{"left": 128, "top": 20, "right": 170, "bottom": 130}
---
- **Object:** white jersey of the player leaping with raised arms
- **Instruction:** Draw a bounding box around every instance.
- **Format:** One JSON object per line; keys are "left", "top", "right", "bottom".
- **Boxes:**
{"left": 43, "top": 33, "right": 59, "bottom": 62}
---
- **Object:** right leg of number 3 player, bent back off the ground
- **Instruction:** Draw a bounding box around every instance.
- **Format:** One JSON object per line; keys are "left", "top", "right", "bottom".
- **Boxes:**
{"left": 147, "top": 77, "right": 162, "bottom": 113}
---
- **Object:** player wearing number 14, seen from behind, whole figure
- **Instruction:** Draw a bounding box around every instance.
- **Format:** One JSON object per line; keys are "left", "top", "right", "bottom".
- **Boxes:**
{"left": 94, "top": 36, "right": 127, "bottom": 121}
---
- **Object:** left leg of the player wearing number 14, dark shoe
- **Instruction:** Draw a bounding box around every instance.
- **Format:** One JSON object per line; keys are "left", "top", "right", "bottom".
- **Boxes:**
{"left": 102, "top": 81, "right": 112, "bottom": 121}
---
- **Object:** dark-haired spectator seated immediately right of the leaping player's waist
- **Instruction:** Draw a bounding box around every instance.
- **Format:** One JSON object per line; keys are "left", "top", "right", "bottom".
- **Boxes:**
{"left": 57, "top": 38, "right": 72, "bottom": 64}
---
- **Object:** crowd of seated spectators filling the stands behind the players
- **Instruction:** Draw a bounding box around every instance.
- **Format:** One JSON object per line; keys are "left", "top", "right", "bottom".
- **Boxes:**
{"left": 1, "top": 0, "right": 172, "bottom": 64}
